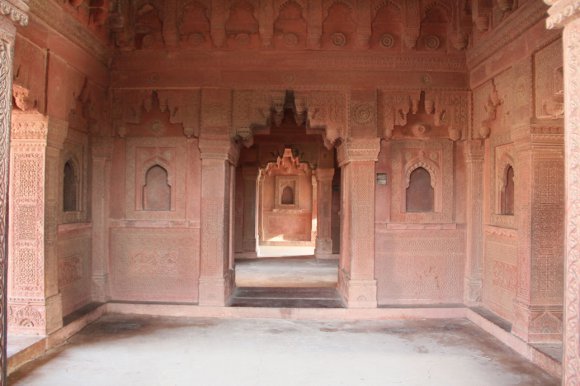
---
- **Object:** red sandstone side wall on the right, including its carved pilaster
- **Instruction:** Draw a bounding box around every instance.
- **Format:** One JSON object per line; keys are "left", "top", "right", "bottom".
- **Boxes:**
{"left": 467, "top": 2, "right": 564, "bottom": 334}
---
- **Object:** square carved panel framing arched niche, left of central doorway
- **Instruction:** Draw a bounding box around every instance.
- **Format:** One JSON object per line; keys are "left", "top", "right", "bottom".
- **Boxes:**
{"left": 125, "top": 138, "right": 187, "bottom": 220}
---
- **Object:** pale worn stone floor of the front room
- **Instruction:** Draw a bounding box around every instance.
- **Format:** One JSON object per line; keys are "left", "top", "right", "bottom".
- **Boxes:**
{"left": 9, "top": 315, "right": 559, "bottom": 386}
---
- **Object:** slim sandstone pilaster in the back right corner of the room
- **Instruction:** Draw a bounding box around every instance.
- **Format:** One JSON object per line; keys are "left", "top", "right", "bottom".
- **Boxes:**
{"left": 464, "top": 140, "right": 484, "bottom": 305}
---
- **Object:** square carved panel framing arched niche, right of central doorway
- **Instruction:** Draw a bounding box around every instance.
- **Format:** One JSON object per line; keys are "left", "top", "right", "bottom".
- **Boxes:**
{"left": 388, "top": 140, "right": 454, "bottom": 223}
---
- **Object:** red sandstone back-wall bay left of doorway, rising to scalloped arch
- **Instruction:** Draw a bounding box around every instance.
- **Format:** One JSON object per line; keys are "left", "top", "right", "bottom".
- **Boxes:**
{"left": 108, "top": 117, "right": 201, "bottom": 303}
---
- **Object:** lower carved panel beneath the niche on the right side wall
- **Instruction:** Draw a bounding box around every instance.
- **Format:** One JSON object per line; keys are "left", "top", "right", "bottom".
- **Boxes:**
{"left": 482, "top": 227, "right": 518, "bottom": 320}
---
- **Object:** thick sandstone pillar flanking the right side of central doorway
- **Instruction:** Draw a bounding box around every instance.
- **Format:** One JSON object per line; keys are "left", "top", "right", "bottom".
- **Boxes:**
{"left": 338, "top": 138, "right": 380, "bottom": 308}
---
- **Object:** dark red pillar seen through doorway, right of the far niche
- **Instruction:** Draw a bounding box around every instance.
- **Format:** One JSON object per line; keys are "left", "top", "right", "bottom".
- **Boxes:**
{"left": 315, "top": 168, "right": 334, "bottom": 257}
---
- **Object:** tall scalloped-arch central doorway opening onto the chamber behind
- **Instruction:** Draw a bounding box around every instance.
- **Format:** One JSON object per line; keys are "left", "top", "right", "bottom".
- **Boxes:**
{"left": 234, "top": 92, "right": 340, "bottom": 307}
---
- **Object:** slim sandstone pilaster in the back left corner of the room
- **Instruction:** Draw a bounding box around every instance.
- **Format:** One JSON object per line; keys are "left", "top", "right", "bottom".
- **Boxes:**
{"left": 91, "top": 138, "right": 113, "bottom": 302}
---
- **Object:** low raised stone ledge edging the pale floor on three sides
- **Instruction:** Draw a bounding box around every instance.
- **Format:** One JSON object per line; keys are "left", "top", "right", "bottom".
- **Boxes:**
{"left": 7, "top": 302, "right": 562, "bottom": 378}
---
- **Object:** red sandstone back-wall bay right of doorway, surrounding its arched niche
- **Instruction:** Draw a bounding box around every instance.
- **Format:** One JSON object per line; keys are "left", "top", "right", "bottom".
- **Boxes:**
{"left": 375, "top": 139, "right": 466, "bottom": 305}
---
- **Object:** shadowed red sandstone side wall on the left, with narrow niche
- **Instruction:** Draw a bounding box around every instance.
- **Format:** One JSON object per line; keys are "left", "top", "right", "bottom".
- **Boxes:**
{"left": 14, "top": 1, "right": 110, "bottom": 319}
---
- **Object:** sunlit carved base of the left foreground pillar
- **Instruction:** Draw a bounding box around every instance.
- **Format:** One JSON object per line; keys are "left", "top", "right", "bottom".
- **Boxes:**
{"left": 8, "top": 294, "right": 62, "bottom": 335}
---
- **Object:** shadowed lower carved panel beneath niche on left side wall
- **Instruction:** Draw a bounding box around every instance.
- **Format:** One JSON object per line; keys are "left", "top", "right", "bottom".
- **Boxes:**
{"left": 58, "top": 225, "right": 92, "bottom": 315}
